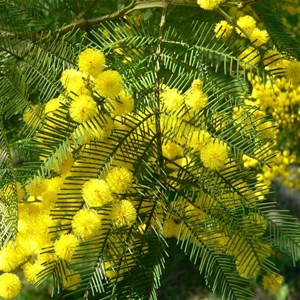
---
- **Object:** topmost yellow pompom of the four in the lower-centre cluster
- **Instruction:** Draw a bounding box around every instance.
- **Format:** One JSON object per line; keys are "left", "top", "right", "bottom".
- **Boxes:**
{"left": 106, "top": 167, "right": 133, "bottom": 194}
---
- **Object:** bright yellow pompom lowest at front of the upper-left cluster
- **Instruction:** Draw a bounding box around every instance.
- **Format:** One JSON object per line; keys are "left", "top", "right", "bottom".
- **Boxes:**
{"left": 69, "top": 95, "right": 97, "bottom": 123}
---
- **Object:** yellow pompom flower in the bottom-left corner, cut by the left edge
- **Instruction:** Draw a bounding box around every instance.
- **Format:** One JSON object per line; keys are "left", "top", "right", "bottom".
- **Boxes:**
{"left": 0, "top": 273, "right": 21, "bottom": 299}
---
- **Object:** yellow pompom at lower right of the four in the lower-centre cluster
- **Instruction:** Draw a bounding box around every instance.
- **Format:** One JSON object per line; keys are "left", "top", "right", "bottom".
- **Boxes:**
{"left": 111, "top": 200, "right": 137, "bottom": 227}
